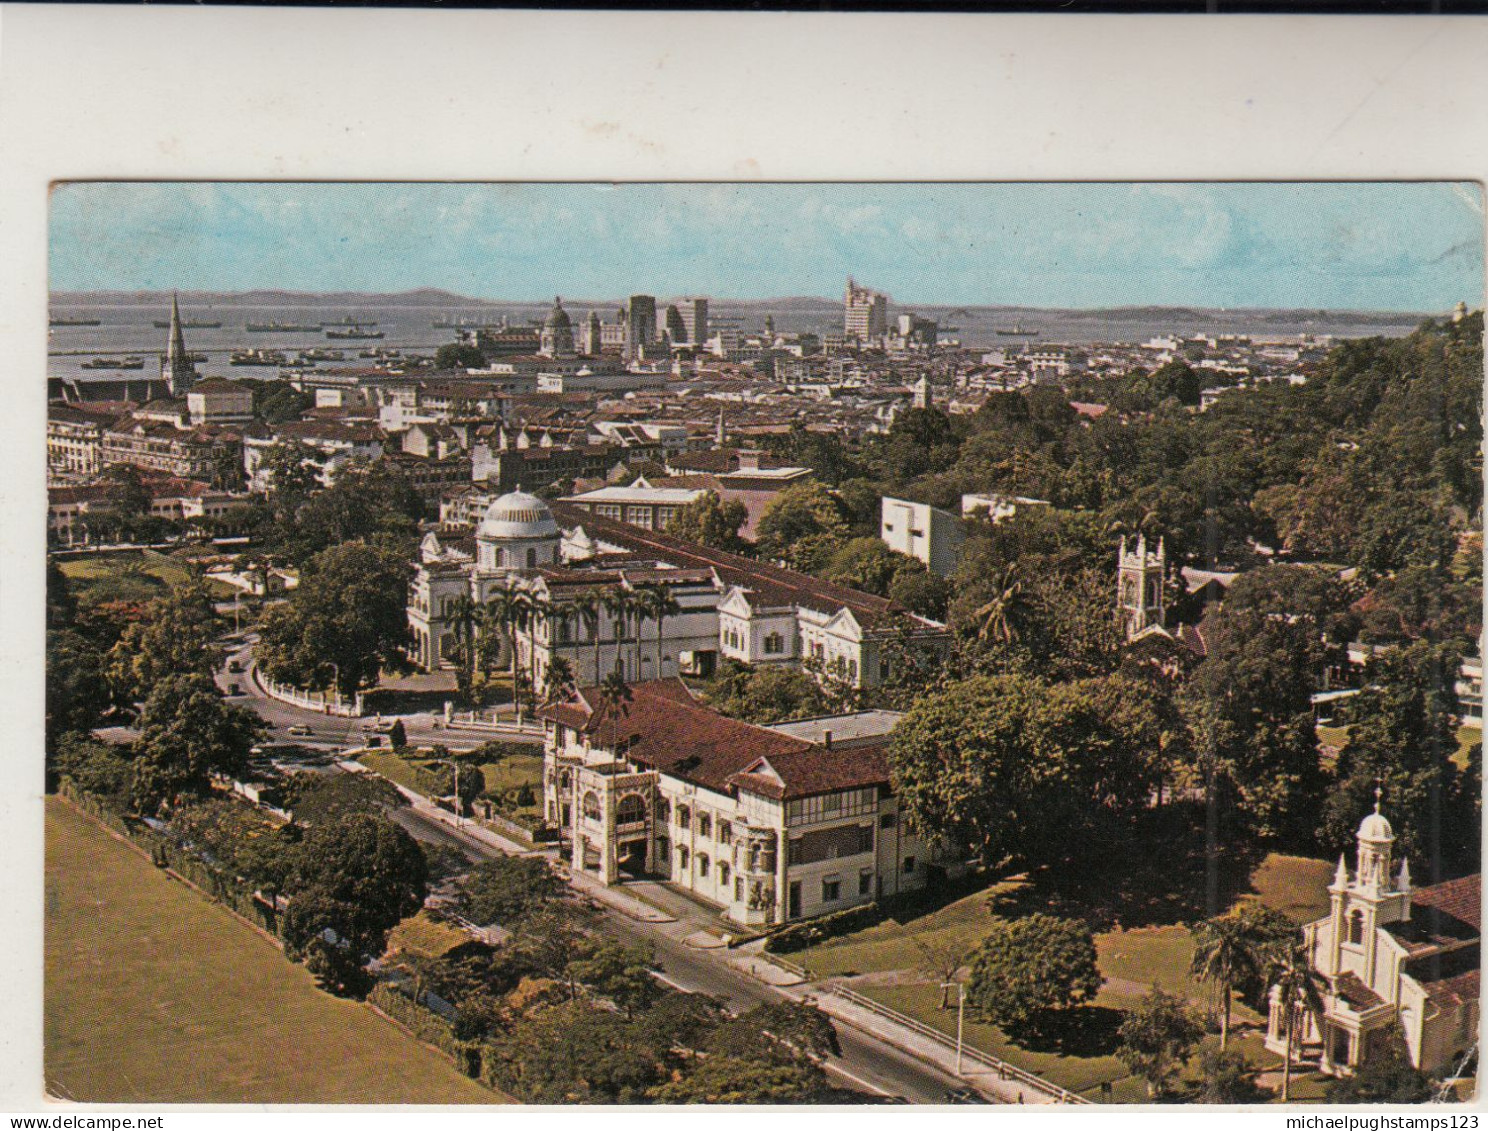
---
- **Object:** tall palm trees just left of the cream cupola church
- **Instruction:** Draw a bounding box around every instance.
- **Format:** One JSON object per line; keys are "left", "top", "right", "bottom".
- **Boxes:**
{"left": 1189, "top": 903, "right": 1327, "bottom": 1101}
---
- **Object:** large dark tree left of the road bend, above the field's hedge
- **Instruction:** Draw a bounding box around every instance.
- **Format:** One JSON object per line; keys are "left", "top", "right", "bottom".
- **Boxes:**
{"left": 131, "top": 673, "right": 262, "bottom": 814}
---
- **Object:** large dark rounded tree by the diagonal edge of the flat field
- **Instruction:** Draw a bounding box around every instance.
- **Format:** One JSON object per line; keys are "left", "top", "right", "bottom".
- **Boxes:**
{"left": 283, "top": 813, "right": 429, "bottom": 991}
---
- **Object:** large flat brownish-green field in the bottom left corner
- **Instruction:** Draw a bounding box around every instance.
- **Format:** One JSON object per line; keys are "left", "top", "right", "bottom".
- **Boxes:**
{"left": 45, "top": 798, "right": 500, "bottom": 1104}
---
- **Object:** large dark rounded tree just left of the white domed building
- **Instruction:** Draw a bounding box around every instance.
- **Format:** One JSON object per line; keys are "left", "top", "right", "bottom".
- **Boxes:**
{"left": 257, "top": 542, "right": 411, "bottom": 698}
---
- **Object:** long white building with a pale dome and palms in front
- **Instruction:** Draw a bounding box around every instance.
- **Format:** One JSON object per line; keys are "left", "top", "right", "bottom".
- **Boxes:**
{"left": 408, "top": 491, "right": 949, "bottom": 686}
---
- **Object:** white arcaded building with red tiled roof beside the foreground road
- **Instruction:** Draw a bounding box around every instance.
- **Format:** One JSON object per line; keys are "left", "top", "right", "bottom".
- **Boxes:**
{"left": 540, "top": 680, "right": 940, "bottom": 927}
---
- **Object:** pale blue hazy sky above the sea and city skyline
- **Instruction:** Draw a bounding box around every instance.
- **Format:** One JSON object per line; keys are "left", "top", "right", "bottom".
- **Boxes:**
{"left": 51, "top": 183, "right": 1484, "bottom": 311}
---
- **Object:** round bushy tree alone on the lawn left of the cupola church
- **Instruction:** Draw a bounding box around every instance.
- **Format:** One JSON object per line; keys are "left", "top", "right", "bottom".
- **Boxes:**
{"left": 967, "top": 914, "right": 1103, "bottom": 1040}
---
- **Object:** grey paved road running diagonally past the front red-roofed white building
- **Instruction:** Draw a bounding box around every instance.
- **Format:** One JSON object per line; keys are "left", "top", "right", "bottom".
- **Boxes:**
{"left": 391, "top": 808, "right": 964, "bottom": 1104}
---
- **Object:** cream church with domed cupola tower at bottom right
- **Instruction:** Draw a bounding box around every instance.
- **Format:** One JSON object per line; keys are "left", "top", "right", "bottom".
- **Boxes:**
{"left": 1266, "top": 792, "right": 1482, "bottom": 1076}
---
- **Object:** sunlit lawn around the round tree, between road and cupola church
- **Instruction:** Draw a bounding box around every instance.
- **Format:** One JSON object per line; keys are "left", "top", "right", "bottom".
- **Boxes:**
{"left": 787, "top": 854, "right": 1333, "bottom": 1103}
